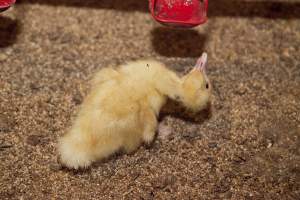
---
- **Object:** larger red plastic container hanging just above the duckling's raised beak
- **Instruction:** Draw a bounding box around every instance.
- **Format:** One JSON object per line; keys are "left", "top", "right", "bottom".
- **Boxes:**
{"left": 150, "top": 0, "right": 208, "bottom": 27}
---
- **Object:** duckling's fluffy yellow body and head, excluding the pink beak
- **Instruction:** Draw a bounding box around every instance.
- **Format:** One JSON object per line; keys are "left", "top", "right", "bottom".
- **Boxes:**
{"left": 58, "top": 57, "right": 210, "bottom": 169}
